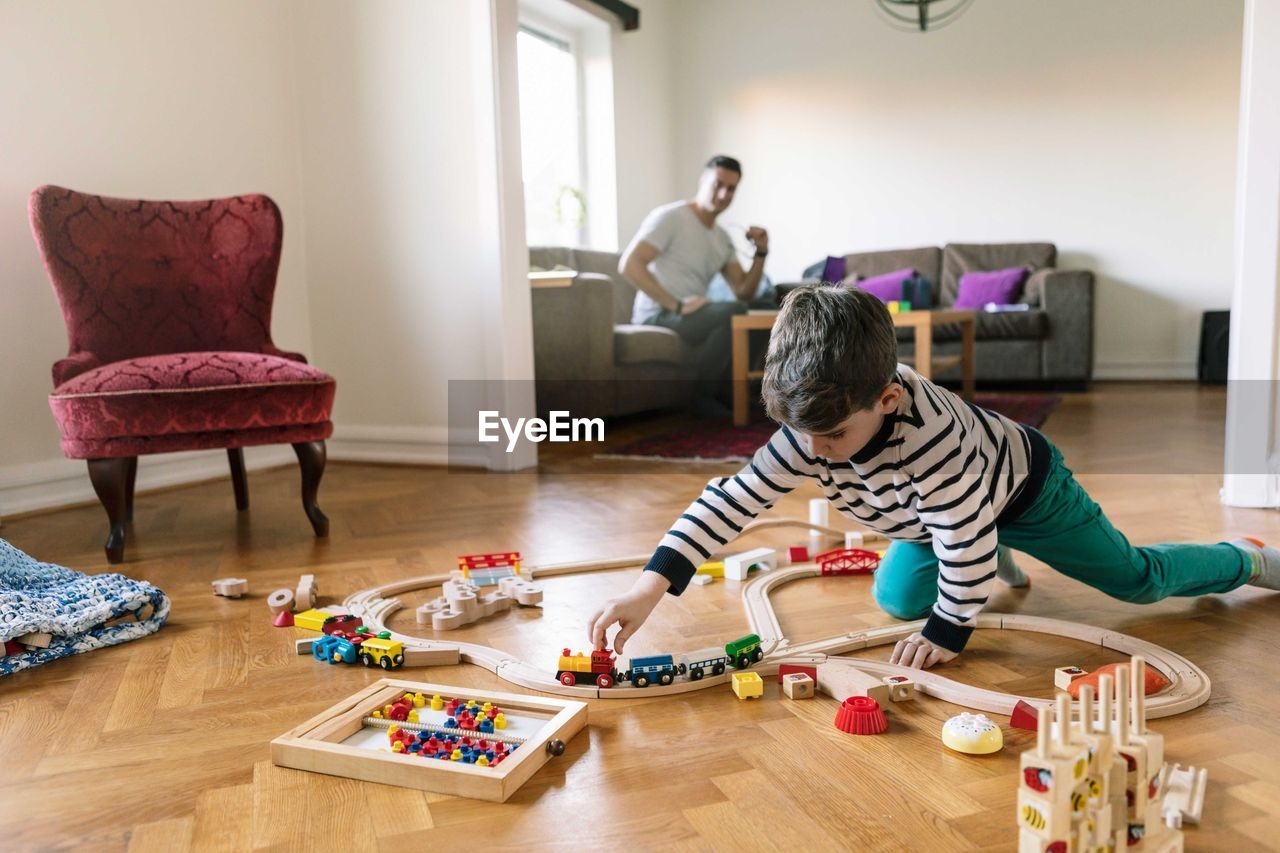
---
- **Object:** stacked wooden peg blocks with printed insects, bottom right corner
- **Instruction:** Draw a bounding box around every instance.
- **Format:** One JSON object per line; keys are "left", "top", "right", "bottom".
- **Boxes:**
{"left": 1018, "top": 656, "right": 1183, "bottom": 853}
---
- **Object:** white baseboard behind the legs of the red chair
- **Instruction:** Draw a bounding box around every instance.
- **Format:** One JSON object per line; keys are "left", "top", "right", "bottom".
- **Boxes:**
{"left": 0, "top": 444, "right": 297, "bottom": 517}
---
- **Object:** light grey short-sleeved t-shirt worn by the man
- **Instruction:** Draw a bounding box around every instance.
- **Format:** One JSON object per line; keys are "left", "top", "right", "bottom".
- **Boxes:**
{"left": 628, "top": 201, "right": 735, "bottom": 323}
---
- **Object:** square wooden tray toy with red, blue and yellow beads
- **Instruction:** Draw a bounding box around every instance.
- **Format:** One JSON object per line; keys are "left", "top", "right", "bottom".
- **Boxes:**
{"left": 271, "top": 679, "right": 586, "bottom": 803}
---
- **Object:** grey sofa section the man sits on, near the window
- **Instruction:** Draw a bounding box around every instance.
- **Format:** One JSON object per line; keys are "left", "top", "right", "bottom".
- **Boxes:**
{"left": 529, "top": 246, "right": 696, "bottom": 418}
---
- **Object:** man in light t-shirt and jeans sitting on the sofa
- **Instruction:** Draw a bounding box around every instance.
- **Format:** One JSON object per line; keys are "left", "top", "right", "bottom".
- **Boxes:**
{"left": 618, "top": 155, "right": 769, "bottom": 382}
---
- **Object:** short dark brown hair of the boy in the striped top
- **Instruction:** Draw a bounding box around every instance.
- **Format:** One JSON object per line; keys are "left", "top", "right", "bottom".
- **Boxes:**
{"left": 764, "top": 284, "right": 897, "bottom": 433}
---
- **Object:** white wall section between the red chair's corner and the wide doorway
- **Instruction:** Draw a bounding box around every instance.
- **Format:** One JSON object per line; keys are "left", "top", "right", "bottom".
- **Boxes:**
{"left": 297, "top": 0, "right": 518, "bottom": 461}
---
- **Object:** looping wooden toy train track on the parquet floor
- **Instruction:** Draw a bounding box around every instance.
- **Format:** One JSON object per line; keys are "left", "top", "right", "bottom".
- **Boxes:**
{"left": 344, "top": 519, "right": 1210, "bottom": 719}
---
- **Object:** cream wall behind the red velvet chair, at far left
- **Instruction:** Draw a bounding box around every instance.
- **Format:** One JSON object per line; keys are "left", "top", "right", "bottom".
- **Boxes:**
{"left": 0, "top": 0, "right": 312, "bottom": 512}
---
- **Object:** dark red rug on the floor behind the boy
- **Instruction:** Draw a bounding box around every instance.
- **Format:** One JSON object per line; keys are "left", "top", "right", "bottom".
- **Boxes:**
{"left": 596, "top": 394, "right": 1062, "bottom": 462}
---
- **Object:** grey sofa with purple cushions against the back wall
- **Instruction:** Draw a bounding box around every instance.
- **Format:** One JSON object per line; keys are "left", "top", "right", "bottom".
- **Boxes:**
{"left": 808, "top": 243, "right": 1093, "bottom": 386}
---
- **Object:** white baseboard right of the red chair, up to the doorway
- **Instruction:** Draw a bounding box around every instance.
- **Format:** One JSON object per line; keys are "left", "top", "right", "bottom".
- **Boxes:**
{"left": 328, "top": 425, "right": 489, "bottom": 467}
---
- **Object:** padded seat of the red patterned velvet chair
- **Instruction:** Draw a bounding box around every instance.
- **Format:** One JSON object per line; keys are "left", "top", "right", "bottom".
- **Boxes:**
{"left": 49, "top": 352, "right": 334, "bottom": 450}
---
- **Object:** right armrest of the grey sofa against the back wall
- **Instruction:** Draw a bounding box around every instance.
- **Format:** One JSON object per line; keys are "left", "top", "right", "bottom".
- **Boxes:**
{"left": 1027, "top": 269, "right": 1093, "bottom": 382}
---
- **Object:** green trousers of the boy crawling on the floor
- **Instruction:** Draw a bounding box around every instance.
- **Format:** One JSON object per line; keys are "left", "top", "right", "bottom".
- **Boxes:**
{"left": 872, "top": 432, "right": 1251, "bottom": 619}
